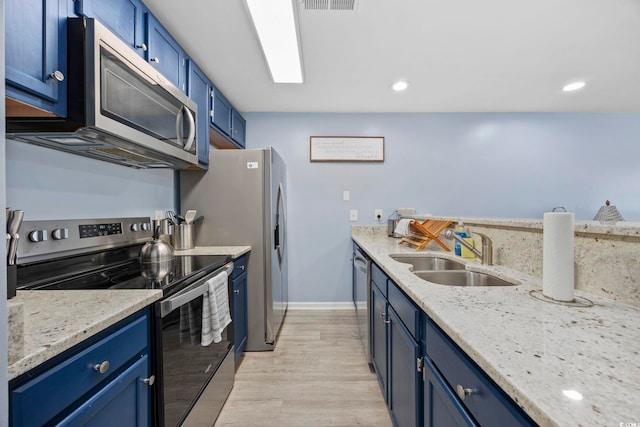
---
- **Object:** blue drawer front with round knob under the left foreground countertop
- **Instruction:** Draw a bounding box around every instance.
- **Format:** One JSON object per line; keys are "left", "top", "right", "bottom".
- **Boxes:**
{"left": 11, "top": 316, "right": 149, "bottom": 426}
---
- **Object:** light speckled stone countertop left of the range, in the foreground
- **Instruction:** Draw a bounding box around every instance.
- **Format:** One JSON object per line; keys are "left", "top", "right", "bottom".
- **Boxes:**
{"left": 9, "top": 289, "right": 162, "bottom": 379}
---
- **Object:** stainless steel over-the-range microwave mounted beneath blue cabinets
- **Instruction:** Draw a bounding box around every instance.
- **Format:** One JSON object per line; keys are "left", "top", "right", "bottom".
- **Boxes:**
{"left": 7, "top": 18, "right": 199, "bottom": 169}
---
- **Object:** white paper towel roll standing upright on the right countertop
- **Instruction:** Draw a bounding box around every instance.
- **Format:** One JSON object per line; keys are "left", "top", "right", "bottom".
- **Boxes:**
{"left": 542, "top": 212, "right": 575, "bottom": 301}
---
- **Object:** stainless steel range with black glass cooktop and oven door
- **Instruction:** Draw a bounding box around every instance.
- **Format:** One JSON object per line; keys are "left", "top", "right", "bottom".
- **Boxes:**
{"left": 17, "top": 217, "right": 235, "bottom": 426}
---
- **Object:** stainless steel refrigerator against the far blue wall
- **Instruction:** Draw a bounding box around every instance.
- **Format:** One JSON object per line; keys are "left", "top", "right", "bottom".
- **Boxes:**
{"left": 180, "top": 147, "right": 289, "bottom": 351}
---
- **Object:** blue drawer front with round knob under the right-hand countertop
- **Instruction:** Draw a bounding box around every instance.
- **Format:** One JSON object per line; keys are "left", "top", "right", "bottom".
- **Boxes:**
{"left": 426, "top": 320, "right": 535, "bottom": 426}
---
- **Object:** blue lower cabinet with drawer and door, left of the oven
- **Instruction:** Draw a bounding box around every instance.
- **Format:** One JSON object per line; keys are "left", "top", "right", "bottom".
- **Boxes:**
{"left": 9, "top": 309, "right": 153, "bottom": 427}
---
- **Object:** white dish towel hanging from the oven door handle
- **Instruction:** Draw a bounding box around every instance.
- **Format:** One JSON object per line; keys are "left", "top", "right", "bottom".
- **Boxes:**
{"left": 201, "top": 271, "right": 231, "bottom": 347}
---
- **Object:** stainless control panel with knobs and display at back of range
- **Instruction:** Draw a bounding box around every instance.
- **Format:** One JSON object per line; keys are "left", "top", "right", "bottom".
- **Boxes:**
{"left": 17, "top": 217, "right": 152, "bottom": 264}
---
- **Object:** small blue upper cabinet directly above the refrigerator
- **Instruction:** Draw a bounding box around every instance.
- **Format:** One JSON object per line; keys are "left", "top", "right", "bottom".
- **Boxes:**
{"left": 211, "top": 87, "right": 246, "bottom": 148}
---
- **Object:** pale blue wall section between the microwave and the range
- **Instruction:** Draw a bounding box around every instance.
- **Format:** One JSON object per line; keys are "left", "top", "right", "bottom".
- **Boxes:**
{"left": 6, "top": 140, "right": 175, "bottom": 221}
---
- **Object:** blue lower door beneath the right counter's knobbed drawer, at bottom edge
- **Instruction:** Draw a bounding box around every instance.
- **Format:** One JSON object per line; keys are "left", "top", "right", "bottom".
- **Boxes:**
{"left": 422, "top": 357, "right": 476, "bottom": 427}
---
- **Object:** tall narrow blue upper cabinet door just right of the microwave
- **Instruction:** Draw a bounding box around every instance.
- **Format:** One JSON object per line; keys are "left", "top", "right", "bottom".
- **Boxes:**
{"left": 187, "top": 60, "right": 211, "bottom": 168}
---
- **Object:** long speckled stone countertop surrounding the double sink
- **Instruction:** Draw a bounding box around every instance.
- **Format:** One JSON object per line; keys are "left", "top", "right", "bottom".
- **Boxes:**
{"left": 352, "top": 227, "right": 640, "bottom": 426}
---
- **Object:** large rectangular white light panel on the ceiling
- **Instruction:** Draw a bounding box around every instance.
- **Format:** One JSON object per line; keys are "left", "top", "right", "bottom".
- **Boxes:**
{"left": 246, "top": 0, "right": 302, "bottom": 83}
